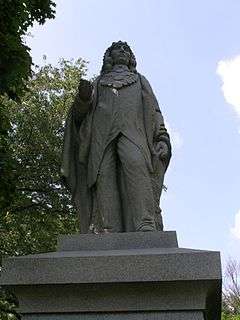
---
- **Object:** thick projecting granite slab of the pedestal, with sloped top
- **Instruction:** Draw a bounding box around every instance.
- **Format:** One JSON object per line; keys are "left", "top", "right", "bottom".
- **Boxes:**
{"left": 1, "top": 248, "right": 221, "bottom": 285}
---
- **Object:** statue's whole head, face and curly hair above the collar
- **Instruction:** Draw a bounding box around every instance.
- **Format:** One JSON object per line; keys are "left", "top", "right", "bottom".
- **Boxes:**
{"left": 101, "top": 41, "right": 137, "bottom": 74}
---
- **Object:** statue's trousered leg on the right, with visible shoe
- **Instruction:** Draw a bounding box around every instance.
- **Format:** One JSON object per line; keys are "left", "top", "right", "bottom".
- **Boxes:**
{"left": 117, "top": 135, "right": 156, "bottom": 231}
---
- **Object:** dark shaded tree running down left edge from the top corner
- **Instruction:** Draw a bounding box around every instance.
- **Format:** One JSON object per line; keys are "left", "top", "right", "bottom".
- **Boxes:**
{"left": 0, "top": 0, "right": 55, "bottom": 209}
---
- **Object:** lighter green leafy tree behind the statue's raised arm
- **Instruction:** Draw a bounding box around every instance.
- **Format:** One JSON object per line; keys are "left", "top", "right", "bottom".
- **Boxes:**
{"left": 0, "top": 59, "right": 86, "bottom": 256}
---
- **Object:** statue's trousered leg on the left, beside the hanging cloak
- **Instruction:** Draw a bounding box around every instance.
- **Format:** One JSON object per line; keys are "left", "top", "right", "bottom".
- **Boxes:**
{"left": 96, "top": 141, "right": 123, "bottom": 232}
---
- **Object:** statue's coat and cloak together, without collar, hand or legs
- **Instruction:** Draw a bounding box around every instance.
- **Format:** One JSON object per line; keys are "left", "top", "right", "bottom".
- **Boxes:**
{"left": 62, "top": 74, "right": 171, "bottom": 233}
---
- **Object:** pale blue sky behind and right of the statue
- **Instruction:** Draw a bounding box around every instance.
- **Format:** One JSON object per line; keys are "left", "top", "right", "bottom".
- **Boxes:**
{"left": 27, "top": 0, "right": 240, "bottom": 260}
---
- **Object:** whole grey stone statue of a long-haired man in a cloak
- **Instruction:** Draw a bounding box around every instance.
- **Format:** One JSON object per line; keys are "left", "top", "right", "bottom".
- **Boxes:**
{"left": 62, "top": 41, "right": 171, "bottom": 233}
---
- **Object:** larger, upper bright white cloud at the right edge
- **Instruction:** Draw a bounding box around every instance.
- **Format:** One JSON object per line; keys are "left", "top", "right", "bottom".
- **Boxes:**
{"left": 217, "top": 55, "right": 240, "bottom": 117}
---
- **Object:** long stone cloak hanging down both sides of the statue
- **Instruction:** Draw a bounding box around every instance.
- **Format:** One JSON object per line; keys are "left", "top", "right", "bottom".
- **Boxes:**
{"left": 61, "top": 74, "right": 171, "bottom": 233}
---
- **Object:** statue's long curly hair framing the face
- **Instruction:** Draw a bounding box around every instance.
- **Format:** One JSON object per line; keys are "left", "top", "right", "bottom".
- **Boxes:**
{"left": 101, "top": 41, "right": 137, "bottom": 75}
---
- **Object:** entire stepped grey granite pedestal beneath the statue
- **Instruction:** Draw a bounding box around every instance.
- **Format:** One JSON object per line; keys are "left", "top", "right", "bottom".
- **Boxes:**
{"left": 0, "top": 231, "right": 221, "bottom": 320}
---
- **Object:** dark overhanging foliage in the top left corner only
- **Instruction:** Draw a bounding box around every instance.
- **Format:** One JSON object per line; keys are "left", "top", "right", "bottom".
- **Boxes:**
{"left": 0, "top": 0, "right": 55, "bottom": 98}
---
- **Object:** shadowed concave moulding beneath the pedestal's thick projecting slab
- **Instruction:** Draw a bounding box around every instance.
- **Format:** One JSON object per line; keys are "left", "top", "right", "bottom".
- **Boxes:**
{"left": 9, "top": 281, "right": 216, "bottom": 313}
